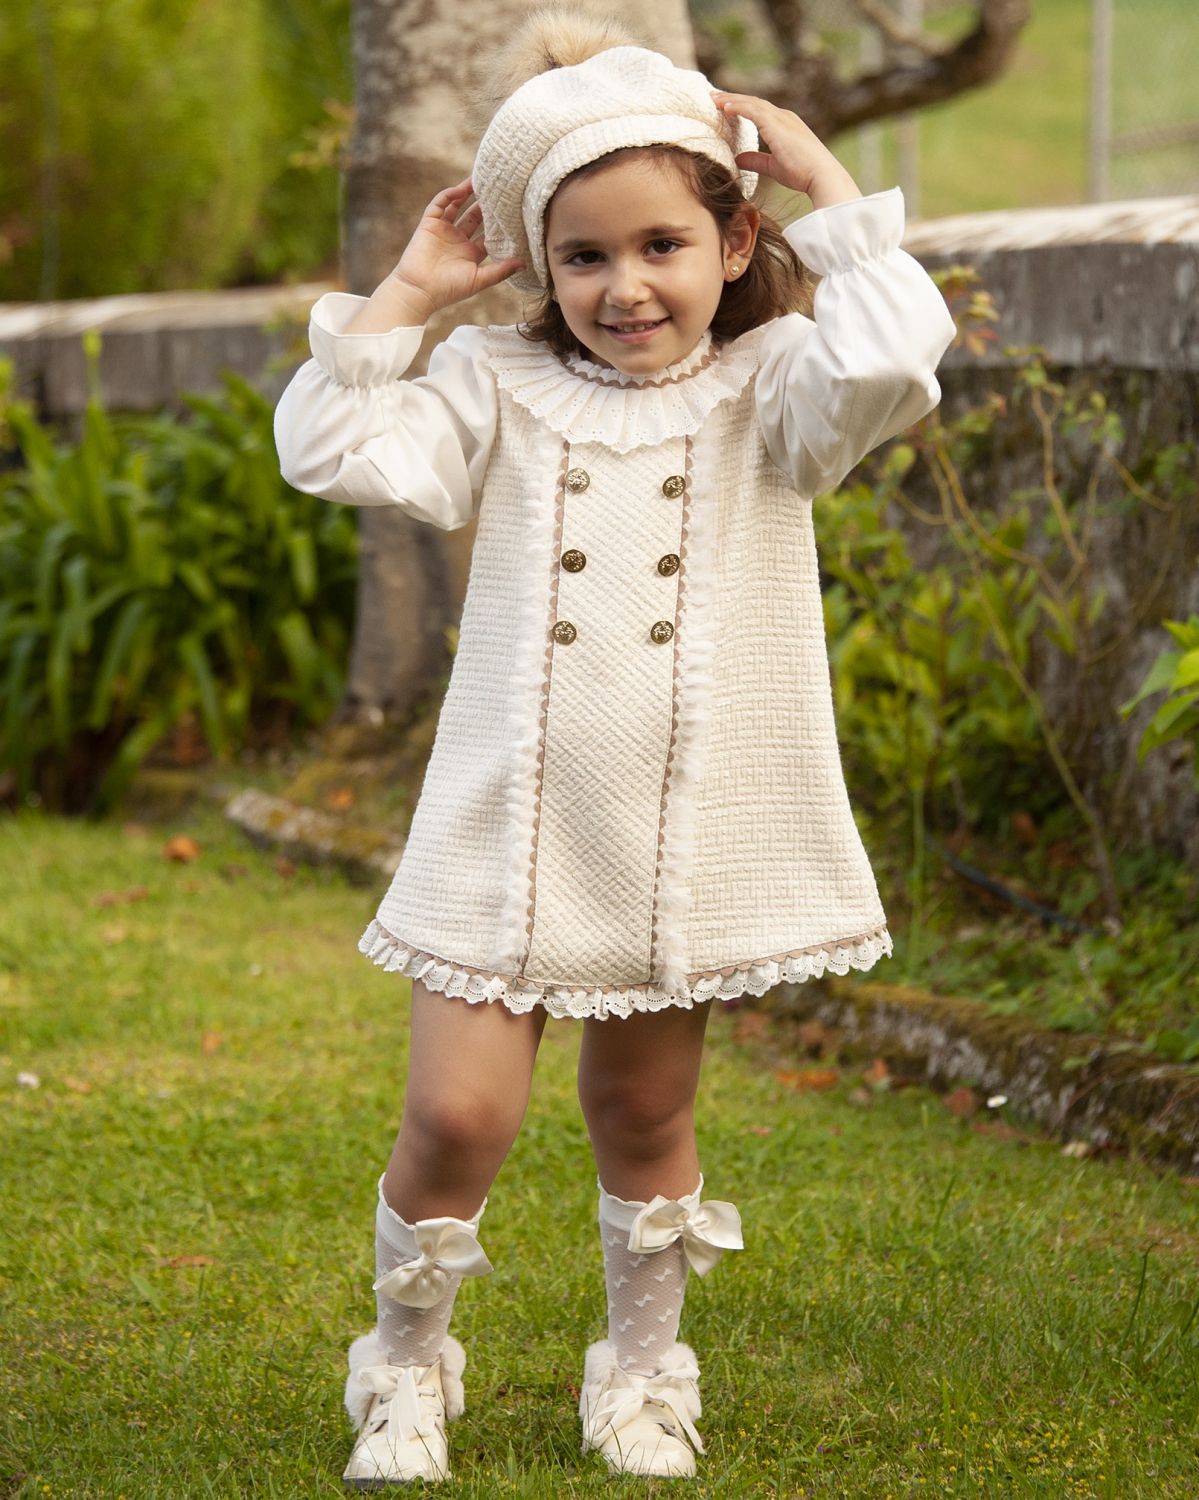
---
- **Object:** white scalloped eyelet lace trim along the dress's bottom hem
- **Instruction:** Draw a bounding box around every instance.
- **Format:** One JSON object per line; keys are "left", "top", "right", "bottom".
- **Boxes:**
{"left": 359, "top": 920, "right": 891, "bottom": 1020}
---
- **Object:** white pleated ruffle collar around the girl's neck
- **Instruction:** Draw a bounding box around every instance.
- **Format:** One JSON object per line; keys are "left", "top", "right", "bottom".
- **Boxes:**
{"left": 488, "top": 324, "right": 768, "bottom": 453}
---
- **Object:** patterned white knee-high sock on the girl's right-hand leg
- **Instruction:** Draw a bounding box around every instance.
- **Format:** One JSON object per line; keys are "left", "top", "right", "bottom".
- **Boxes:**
{"left": 599, "top": 1178, "right": 704, "bottom": 1376}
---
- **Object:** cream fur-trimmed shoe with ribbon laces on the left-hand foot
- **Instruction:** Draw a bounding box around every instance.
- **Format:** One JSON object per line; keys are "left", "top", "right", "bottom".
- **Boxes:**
{"left": 342, "top": 1334, "right": 465, "bottom": 1490}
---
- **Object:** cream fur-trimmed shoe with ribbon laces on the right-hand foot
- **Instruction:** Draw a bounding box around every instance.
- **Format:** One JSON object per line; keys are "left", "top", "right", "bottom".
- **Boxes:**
{"left": 579, "top": 1338, "right": 704, "bottom": 1478}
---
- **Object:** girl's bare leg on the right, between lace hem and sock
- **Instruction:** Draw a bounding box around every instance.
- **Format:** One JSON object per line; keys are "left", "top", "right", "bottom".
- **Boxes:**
{"left": 579, "top": 1004, "right": 711, "bottom": 1202}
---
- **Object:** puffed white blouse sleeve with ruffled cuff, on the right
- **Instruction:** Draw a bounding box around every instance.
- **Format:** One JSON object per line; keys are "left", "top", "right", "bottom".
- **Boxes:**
{"left": 755, "top": 188, "right": 954, "bottom": 498}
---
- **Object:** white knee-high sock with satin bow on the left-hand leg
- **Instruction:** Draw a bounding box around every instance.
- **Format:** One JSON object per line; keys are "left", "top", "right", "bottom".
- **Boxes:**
{"left": 375, "top": 1178, "right": 491, "bottom": 1365}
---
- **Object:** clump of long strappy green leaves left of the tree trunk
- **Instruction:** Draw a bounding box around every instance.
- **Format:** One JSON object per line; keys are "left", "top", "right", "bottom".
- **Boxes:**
{"left": 0, "top": 335, "right": 357, "bottom": 812}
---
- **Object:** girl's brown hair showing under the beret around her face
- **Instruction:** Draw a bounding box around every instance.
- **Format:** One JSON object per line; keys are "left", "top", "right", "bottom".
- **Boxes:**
{"left": 519, "top": 146, "right": 812, "bottom": 359}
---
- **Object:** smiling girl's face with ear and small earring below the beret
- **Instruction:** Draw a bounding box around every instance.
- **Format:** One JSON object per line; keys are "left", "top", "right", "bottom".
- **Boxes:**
{"left": 545, "top": 158, "right": 755, "bottom": 375}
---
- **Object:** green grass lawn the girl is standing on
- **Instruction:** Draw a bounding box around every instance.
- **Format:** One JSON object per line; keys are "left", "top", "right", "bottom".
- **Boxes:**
{"left": 0, "top": 809, "right": 1199, "bottom": 1500}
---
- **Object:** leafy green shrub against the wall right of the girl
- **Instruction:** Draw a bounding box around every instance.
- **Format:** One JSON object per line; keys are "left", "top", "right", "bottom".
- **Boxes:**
{"left": 816, "top": 267, "right": 1199, "bottom": 948}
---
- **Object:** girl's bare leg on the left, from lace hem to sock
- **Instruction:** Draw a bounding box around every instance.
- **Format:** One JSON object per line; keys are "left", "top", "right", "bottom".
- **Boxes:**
{"left": 383, "top": 980, "right": 546, "bottom": 1224}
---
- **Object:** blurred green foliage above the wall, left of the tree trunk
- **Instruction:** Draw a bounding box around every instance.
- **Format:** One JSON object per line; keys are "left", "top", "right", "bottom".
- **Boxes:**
{"left": 0, "top": 0, "right": 350, "bottom": 300}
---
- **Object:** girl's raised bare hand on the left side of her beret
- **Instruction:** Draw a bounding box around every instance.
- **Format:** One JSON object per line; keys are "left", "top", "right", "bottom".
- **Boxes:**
{"left": 390, "top": 177, "right": 525, "bottom": 323}
